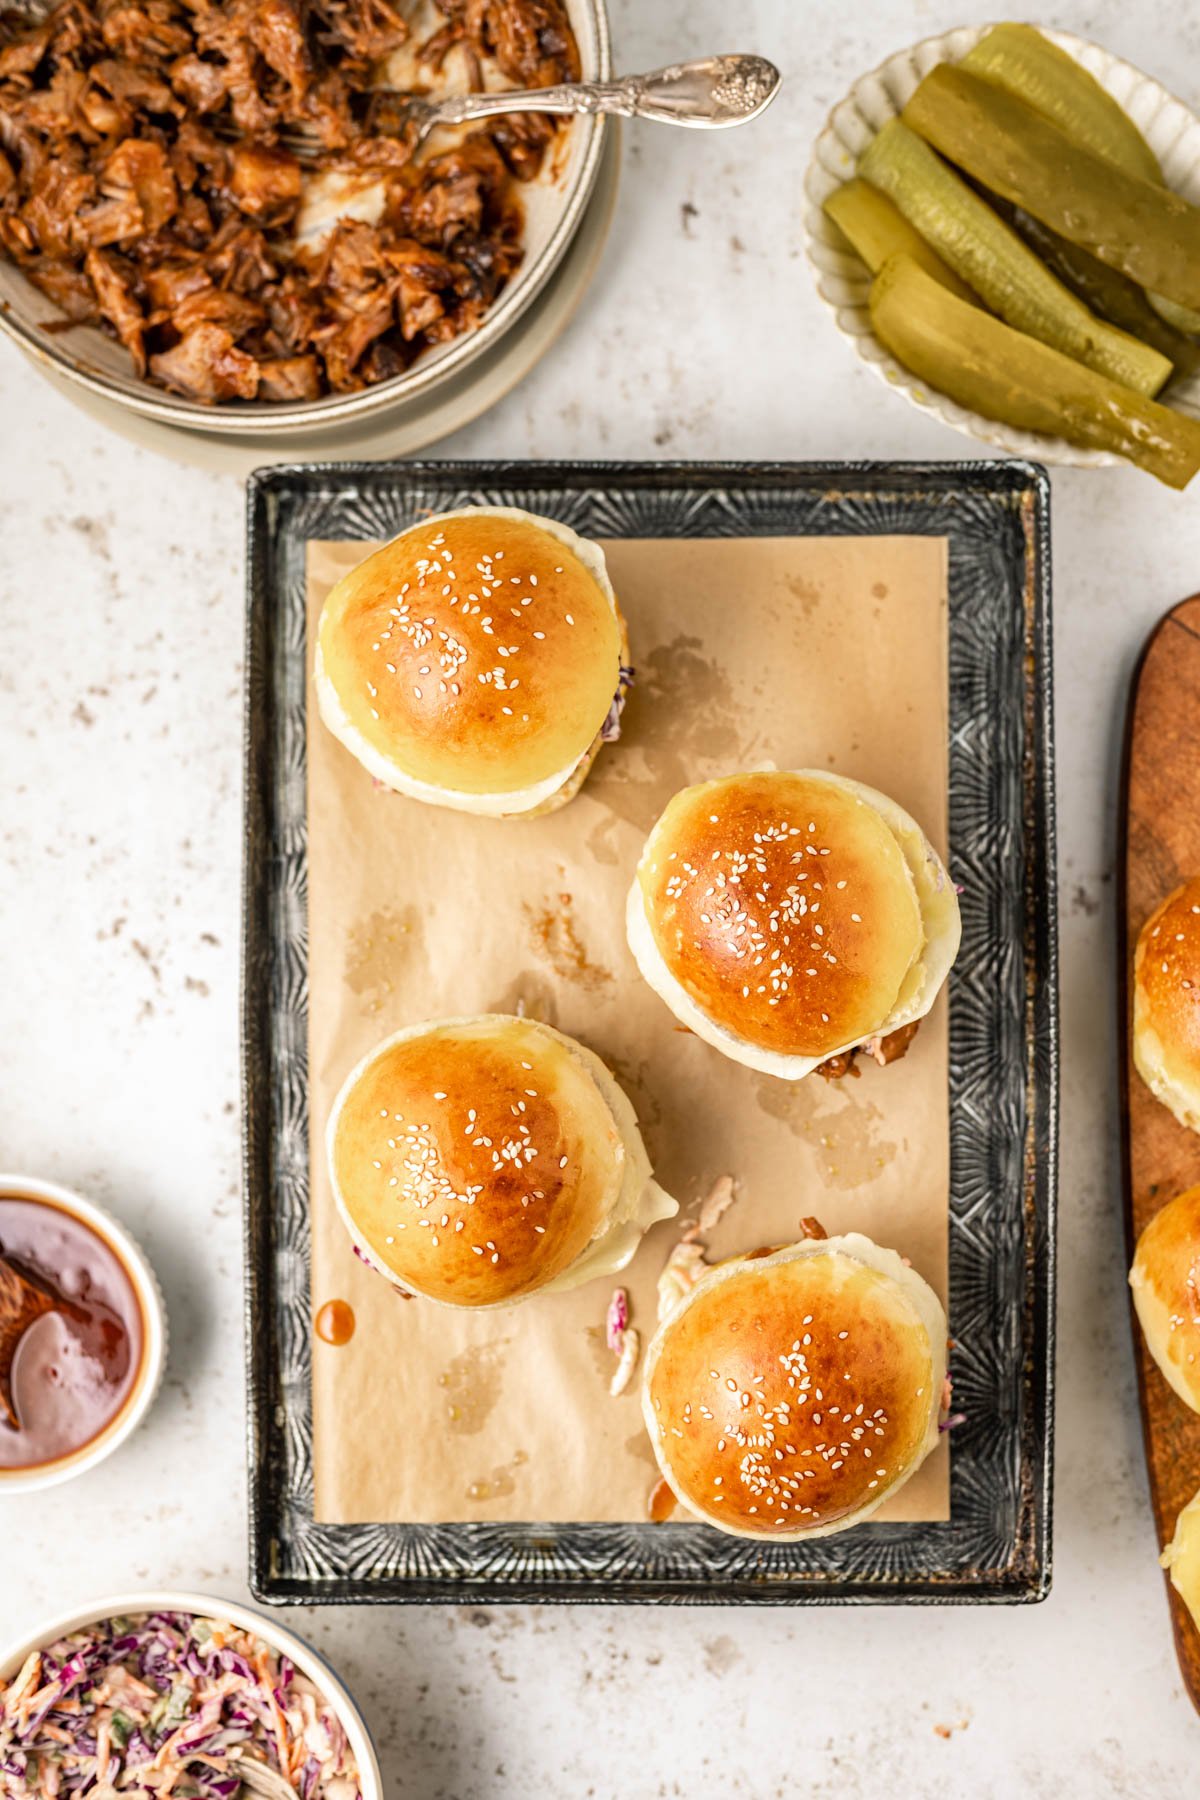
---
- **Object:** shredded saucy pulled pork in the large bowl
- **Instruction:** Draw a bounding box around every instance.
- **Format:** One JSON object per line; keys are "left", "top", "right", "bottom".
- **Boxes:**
{"left": 0, "top": 0, "right": 579, "bottom": 401}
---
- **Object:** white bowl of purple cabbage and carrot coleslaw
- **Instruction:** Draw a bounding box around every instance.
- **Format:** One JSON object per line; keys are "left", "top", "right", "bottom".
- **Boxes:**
{"left": 0, "top": 1591, "right": 383, "bottom": 1800}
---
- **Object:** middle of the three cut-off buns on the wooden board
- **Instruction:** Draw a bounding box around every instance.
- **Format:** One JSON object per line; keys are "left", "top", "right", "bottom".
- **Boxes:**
{"left": 1130, "top": 1186, "right": 1200, "bottom": 1413}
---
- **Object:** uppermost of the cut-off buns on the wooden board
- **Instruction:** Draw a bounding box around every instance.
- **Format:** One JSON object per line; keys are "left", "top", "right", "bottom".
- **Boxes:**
{"left": 1133, "top": 875, "right": 1200, "bottom": 1130}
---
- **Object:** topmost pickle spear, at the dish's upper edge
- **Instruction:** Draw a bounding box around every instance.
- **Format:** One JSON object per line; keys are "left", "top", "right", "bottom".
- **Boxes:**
{"left": 959, "top": 25, "right": 1162, "bottom": 182}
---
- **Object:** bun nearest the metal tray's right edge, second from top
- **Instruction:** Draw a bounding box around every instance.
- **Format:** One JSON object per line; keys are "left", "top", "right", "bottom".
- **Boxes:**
{"left": 626, "top": 769, "right": 961, "bottom": 1080}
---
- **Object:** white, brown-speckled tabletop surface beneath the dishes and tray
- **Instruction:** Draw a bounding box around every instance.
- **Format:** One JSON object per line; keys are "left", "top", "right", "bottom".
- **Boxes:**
{"left": 0, "top": 0, "right": 1200, "bottom": 1800}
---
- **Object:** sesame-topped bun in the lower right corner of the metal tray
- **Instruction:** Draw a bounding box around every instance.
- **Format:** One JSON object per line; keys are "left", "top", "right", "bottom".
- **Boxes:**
{"left": 642, "top": 1233, "right": 946, "bottom": 1541}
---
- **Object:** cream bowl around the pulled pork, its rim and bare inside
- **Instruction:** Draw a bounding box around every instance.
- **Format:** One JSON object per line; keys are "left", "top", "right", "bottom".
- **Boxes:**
{"left": 0, "top": 0, "right": 612, "bottom": 437}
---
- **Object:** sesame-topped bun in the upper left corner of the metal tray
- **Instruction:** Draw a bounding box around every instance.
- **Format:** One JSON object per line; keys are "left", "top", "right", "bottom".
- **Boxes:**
{"left": 315, "top": 506, "right": 628, "bottom": 817}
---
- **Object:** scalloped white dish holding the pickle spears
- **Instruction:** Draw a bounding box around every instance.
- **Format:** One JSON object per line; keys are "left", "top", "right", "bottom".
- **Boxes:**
{"left": 804, "top": 25, "right": 1200, "bottom": 468}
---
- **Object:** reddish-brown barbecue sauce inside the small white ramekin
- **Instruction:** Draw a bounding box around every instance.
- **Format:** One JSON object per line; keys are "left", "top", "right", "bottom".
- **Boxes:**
{"left": 0, "top": 1193, "right": 146, "bottom": 1461}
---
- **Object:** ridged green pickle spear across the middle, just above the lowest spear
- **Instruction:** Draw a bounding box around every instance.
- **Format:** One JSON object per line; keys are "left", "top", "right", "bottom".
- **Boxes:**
{"left": 858, "top": 123, "right": 1171, "bottom": 394}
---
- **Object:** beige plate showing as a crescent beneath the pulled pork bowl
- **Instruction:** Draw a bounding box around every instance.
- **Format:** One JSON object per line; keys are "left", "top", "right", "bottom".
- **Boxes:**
{"left": 30, "top": 119, "right": 621, "bottom": 481}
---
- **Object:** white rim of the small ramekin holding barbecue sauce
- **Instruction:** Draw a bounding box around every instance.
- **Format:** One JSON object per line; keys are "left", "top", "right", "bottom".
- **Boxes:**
{"left": 0, "top": 1174, "right": 167, "bottom": 1499}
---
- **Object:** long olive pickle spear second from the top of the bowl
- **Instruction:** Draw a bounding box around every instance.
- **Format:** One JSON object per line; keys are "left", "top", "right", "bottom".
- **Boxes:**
{"left": 901, "top": 63, "right": 1200, "bottom": 308}
